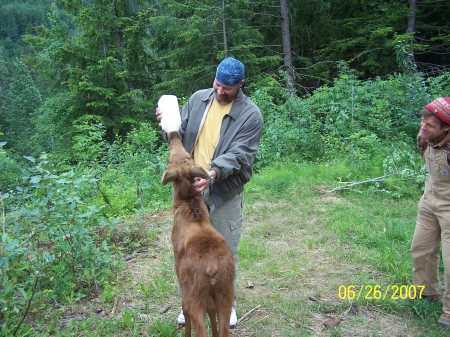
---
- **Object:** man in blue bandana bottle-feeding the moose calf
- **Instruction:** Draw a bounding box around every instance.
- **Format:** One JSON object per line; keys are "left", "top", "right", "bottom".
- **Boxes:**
{"left": 156, "top": 57, "right": 263, "bottom": 326}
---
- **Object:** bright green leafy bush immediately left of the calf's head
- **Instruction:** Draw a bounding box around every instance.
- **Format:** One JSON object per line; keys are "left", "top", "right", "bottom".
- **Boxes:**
{"left": 93, "top": 123, "right": 170, "bottom": 215}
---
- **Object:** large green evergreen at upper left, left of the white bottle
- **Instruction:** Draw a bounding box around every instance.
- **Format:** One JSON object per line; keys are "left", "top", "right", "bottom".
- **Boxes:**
{"left": 28, "top": 0, "right": 156, "bottom": 152}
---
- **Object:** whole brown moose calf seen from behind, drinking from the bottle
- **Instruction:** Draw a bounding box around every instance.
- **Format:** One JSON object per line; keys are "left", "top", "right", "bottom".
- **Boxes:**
{"left": 162, "top": 132, "right": 235, "bottom": 337}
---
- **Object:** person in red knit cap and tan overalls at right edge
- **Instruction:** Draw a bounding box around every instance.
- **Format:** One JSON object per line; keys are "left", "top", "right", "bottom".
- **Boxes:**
{"left": 411, "top": 97, "right": 450, "bottom": 327}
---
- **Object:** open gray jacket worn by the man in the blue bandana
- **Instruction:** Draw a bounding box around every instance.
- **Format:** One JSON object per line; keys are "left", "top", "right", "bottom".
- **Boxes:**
{"left": 181, "top": 88, "right": 263, "bottom": 206}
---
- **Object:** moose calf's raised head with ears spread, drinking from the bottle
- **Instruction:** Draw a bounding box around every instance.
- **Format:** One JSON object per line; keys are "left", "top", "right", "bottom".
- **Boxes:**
{"left": 161, "top": 132, "right": 209, "bottom": 200}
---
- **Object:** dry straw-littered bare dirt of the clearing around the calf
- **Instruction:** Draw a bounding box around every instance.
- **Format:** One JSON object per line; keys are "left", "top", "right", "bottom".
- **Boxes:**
{"left": 52, "top": 200, "right": 423, "bottom": 337}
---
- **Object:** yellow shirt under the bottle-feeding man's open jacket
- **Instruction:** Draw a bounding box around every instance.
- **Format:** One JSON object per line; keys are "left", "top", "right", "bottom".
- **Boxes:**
{"left": 194, "top": 99, "right": 233, "bottom": 171}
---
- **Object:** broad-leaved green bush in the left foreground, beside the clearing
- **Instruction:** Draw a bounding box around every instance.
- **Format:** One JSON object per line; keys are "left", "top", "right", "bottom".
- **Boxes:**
{"left": 0, "top": 155, "right": 116, "bottom": 332}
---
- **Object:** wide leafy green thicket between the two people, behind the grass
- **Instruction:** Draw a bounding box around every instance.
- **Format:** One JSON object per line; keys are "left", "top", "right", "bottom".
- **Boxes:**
{"left": 252, "top": 64, "right": 450, "bottom": 168}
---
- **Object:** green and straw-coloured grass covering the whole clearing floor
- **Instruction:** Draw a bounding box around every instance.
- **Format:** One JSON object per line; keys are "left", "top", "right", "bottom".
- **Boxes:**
{"left": 12, "top": 159, "right": 448, "bottom": 337}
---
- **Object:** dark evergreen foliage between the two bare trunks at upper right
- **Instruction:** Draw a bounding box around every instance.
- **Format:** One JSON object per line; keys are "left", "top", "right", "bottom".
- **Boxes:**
{"left": 294, "top": 0, "right": 409, "bottom": 82}
